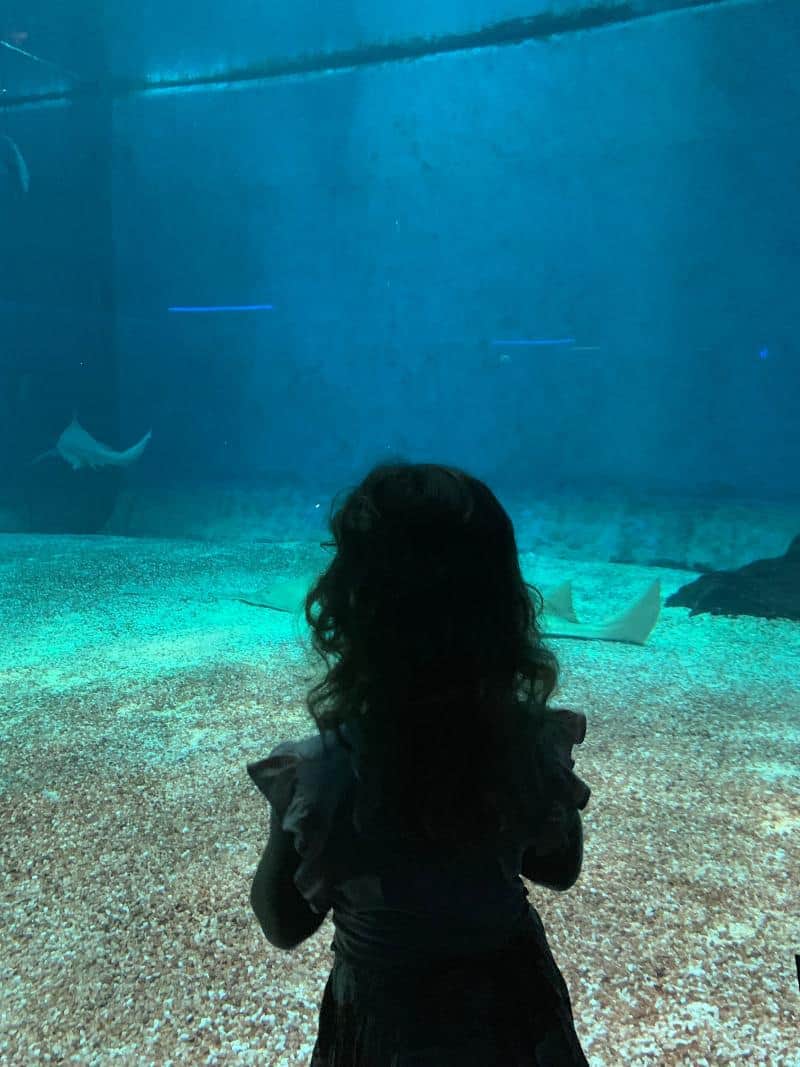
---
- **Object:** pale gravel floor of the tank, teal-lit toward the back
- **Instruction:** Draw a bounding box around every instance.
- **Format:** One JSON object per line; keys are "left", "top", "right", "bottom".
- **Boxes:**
{"left": 0, "top": 536, "right": 800, "bottom": 1067}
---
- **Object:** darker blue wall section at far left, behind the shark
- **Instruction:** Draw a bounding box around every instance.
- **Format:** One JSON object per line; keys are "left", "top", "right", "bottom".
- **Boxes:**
{"left": 0, "top": 0, "right": 119, "bottom": 531}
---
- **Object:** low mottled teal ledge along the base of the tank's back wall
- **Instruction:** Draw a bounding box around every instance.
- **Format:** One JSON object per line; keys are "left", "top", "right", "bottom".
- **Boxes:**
{"left": 108, "top": 488, "right": 800, "bottom": 570}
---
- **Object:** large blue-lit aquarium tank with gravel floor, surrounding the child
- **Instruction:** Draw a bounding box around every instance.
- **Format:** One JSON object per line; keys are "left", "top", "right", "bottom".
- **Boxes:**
{"left": 0, "top": 0, "right": 800, "bottom": 1067}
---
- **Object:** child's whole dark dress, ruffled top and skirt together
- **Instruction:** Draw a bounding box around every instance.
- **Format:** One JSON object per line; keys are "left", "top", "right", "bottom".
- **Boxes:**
{"left": 247, "top": 711, "right": 590, "bottom": 1067}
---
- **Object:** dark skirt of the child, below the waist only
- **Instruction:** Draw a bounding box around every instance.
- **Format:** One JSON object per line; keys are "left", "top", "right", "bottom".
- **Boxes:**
{"left": 311, "top": 907, "right": 589, "bottom": 1067}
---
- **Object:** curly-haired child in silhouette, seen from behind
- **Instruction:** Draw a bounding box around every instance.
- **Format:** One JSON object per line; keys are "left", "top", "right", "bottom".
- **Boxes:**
{"left": 247, "top": 463, "right": 590, "bottom": 1067}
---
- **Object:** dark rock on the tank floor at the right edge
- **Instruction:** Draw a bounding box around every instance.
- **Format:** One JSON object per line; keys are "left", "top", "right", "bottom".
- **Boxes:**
{"left": 667, "top": 534, "right": 800, "bottom": 622}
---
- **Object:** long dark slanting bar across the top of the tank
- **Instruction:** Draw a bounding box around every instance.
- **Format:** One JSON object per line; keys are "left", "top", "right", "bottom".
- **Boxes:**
{"left": 0, "top": 0, "right": 752, "bottom": 109}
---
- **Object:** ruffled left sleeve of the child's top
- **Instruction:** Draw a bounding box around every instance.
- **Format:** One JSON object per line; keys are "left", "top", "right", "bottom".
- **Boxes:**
{"left": 247, "top": 734, "right": 354, "bottom": 914}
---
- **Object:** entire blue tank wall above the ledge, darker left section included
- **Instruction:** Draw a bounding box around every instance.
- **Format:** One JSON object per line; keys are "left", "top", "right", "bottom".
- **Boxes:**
{"left": 2, "top": 0, "right": 800, "bottom": 537}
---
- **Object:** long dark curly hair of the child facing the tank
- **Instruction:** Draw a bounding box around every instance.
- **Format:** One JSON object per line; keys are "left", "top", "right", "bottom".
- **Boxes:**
{"left": 305, "top": 462, "right": 558, "bottom": 844}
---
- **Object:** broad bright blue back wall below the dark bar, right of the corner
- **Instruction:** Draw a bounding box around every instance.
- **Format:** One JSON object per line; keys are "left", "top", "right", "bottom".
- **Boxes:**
{"left": 108, "top": 0, "right": 800, "bottom": 493}
